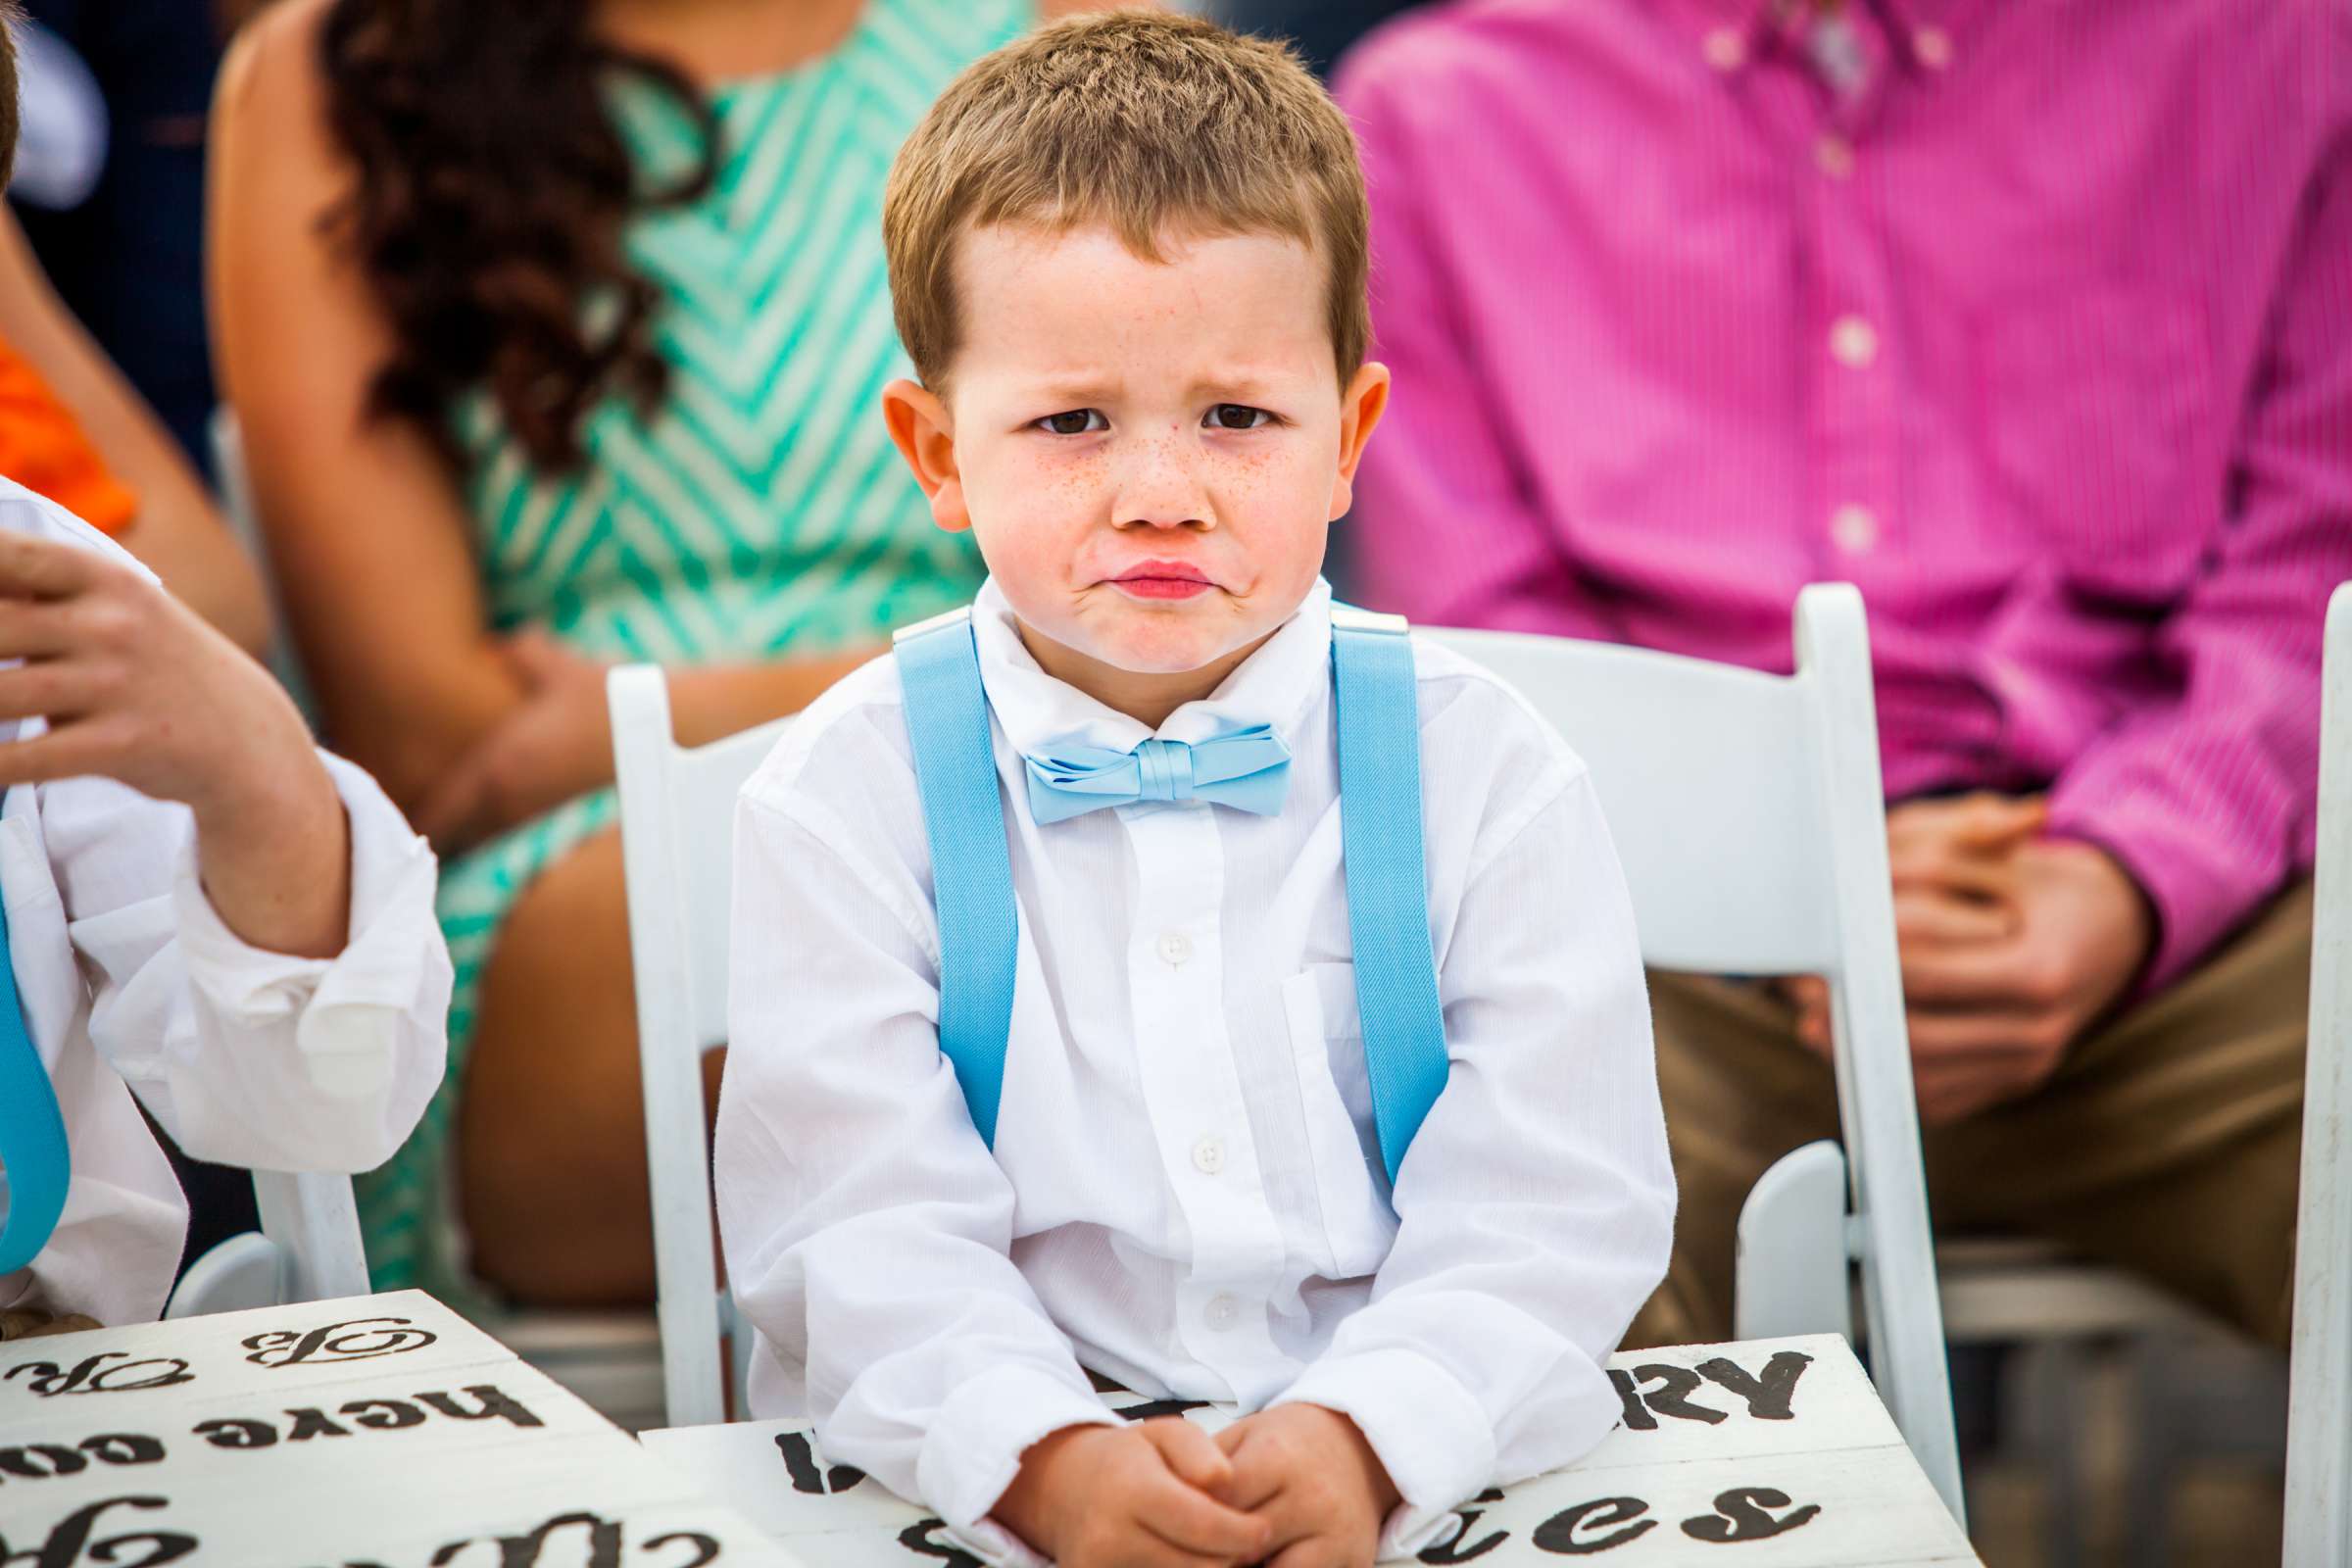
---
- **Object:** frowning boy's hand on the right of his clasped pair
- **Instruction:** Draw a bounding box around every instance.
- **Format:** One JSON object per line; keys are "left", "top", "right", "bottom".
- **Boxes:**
{"left": 1211, "top": 1403, "right": 1399, "bottom": 1568}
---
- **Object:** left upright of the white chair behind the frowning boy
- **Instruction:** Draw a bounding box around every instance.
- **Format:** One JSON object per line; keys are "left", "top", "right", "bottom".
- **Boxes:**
{"left": 605, "top": 665, "right": 788, "bottom": 1427}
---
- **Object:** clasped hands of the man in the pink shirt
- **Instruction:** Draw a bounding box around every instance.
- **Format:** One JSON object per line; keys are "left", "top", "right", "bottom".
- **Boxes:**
{"left": 1783, "top": 795, "right": 2157, "bottom": 1121}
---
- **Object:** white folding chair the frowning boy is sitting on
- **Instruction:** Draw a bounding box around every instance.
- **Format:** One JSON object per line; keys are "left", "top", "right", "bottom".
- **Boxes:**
{"left": 607, "top": 585, "right": 1962, "bottom": 1516}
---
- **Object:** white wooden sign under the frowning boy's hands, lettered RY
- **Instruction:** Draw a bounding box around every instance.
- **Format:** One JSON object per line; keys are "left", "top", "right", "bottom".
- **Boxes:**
{"left": 642, "top": 1336, "right": 1978, "bottom": 1568}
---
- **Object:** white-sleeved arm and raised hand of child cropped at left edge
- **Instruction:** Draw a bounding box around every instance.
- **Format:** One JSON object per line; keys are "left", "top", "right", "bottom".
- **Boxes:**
{"left": 0, "top": 516, "right": 449, "bottom": 1171}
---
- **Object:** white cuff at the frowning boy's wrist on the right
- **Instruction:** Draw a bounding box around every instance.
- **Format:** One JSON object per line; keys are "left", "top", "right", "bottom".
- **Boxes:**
{"left": 1272, "top": 1348, "right": 1494, "bottom": 1561}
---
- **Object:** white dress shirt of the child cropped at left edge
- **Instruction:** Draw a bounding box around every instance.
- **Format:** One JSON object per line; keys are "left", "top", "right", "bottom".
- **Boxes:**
{"left": 0, "top": 479, "right": 449, "bottom": 1324}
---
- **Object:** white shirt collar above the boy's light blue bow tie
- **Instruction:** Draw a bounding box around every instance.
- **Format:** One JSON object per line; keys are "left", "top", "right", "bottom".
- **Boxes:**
{"left": 971, "top": 578, "right": 1331, "bottom": 755}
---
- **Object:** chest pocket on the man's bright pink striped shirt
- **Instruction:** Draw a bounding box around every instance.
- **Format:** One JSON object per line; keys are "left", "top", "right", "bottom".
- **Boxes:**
{"left": 1976, "top": 279, "right": 2218, "bottom": 604}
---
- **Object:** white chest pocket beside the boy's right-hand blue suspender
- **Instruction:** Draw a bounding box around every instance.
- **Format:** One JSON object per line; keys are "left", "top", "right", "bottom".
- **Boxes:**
{"left": 1282, "top": 964, "right": 1397, "bottom": 1279}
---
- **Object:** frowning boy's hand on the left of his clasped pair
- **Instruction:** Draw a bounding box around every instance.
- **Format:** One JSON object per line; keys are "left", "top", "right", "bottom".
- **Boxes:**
{"left": 990, "top": 1415, "right": 1270, "bottom": 1568}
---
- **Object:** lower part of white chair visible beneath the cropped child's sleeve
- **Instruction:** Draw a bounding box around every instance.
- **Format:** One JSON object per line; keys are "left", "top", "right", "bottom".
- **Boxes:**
{"left": 163, "top": 1171, "right": 369, "bottom": 1316}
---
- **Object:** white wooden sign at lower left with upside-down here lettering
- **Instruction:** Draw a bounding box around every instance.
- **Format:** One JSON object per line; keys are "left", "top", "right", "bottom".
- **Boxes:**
{"left": 0, "top": 1291, "right": 798, "bottom": 1568}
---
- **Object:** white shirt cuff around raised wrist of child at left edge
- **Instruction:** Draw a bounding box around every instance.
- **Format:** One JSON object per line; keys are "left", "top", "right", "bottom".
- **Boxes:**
{"left": 172, "top": 753, "right": 437, "bottom": 1101}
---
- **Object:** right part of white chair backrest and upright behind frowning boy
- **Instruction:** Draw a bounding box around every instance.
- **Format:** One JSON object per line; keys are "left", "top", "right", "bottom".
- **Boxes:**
{"left": 1418, "top": 583, "right": 1962, "bottom": 1519}
